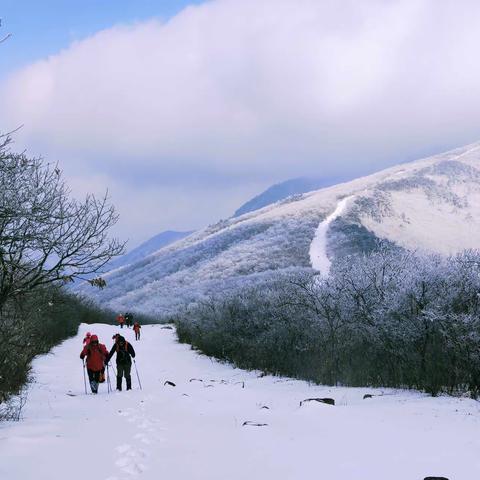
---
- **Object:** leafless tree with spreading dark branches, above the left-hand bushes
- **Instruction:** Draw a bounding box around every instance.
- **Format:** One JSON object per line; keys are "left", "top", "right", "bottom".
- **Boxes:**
{"left": 0, "top": 137, "right": 124, "bottom": 309}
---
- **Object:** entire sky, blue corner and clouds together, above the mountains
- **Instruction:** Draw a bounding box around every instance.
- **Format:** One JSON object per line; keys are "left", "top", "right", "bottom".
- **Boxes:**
{"left": 0, "top": 0, "right": 480, "bottom": 248}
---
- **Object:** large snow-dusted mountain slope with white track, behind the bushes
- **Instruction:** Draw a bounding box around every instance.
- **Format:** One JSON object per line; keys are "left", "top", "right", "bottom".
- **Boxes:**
{"left": 82, "top": 143, "right": 480, "bottom": 314}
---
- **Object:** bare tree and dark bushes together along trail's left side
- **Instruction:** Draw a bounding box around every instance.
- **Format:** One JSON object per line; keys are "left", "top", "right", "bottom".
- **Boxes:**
{"left": 0, "top": 136, "right": 124, "bottom": 416}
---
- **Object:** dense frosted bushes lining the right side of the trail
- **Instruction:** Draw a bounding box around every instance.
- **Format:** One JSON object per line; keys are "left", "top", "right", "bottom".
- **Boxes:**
{"left": 175, "top": 247, "right": 480, "bottom": 397}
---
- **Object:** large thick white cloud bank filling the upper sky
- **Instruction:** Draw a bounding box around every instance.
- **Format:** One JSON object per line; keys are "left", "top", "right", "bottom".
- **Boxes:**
{"left": 0, "top": 0, "right": 480, "bottom": 240}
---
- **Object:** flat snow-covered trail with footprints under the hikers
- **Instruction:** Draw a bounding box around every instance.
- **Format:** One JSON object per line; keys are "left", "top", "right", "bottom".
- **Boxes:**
{"left": 0, "top": 325, "right": 480, "bottom": 480}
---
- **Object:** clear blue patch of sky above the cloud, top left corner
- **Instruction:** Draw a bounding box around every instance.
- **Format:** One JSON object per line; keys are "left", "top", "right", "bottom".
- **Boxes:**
{"left": 0, "top": 0, "right": 202, "bottom": 75}
